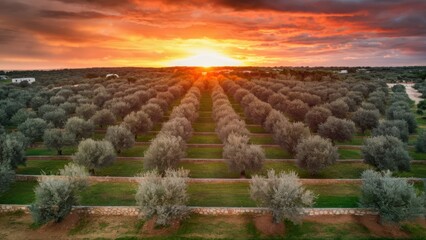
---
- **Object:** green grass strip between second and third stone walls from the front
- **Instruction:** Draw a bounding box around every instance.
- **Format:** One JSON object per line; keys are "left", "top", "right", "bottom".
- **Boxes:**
{"left": 17, "top": 160, "right": 426, "bottom": 179}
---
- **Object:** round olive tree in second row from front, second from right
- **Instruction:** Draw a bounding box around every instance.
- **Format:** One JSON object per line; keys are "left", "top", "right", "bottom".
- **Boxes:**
{"left": 296, "top": 136, "right": 339, "bottom": 175}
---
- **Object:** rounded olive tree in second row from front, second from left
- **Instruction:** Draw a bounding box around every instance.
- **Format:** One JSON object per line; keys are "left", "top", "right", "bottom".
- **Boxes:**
{"left": 72, "top": 138, "right": 116, "bottom": 175}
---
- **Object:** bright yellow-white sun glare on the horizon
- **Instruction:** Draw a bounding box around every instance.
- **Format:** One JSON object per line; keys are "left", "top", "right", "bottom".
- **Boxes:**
{"left": 168, "top": 51, "right": 242, "bottom": 68}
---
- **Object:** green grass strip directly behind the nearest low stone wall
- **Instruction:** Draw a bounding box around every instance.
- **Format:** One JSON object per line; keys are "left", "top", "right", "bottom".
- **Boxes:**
{"left": 0, "top": 182, "right": 359, "bottom": 207}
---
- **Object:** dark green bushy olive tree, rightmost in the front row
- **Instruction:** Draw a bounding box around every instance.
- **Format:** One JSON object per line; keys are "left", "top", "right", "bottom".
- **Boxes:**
{"left": 360, "top": 170, "right": 424, "bottom": 223}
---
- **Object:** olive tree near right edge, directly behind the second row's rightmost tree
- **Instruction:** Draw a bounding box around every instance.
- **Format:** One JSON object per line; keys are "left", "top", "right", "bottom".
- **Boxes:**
{"left": 372, "top": 120, "right": 410, "bottom": 142}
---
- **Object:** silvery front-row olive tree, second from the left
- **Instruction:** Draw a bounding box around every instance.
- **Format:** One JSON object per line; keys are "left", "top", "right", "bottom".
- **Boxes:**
{"left": 135, "top": 169, "right": 189, "bottom": 226}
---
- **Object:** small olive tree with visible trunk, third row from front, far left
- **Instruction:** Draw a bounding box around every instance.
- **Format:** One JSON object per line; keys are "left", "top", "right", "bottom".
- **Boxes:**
{"left": 43, "top": 128, "right": 75, "bottom": 155}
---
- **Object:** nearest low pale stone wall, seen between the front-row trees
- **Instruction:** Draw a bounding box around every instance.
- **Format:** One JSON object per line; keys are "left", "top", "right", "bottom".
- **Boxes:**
{"left": 0, "top": 204, "right": 377, "bottom": 216}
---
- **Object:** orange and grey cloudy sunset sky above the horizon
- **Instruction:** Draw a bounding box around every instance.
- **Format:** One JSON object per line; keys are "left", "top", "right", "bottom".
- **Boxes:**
{"left": 0, "top": 0, "right": 426, "bottom": 70}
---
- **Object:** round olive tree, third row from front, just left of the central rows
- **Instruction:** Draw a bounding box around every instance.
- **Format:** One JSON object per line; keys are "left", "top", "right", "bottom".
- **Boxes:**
{"left": 105, "top": 126, "right": 135, "bottom": 153}
